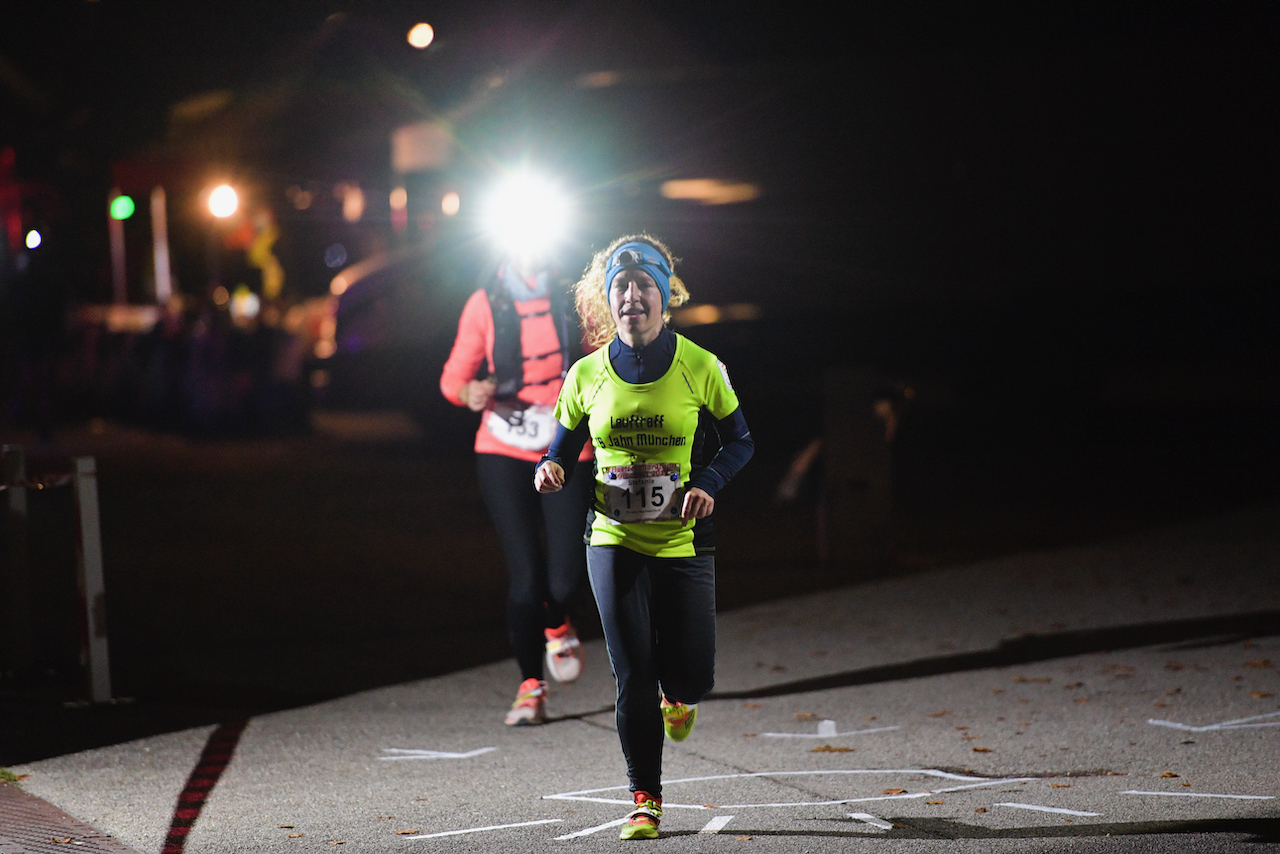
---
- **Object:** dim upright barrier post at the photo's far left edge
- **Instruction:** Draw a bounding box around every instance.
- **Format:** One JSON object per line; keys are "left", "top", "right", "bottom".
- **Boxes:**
{"left": 0, "top": 444, "right": 36, "bottom": 672}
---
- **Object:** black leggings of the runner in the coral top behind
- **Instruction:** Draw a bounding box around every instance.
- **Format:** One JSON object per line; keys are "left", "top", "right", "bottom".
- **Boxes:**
{"left": 476, "top": 453, "right": 595, "bottom": 679}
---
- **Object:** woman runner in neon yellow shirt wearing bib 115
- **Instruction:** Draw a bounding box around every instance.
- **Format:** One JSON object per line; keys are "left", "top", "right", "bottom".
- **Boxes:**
{"left": 534, "top": 234, "right": 754, "bottom": 839}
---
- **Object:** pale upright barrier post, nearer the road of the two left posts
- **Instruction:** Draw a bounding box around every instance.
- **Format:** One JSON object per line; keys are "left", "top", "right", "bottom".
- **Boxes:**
{"left": 73, "top": 457, "right": 111, "bottom": 703}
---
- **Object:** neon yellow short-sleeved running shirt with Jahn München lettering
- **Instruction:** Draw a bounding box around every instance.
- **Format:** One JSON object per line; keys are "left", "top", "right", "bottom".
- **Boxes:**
{"left": 556, "top": 334, "right": 739, "bottom": 557}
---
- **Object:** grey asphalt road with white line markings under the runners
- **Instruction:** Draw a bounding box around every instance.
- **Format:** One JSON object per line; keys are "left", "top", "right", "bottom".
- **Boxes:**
{"left": 12, "top": 508, "right": 1280, "bottom": 853}
